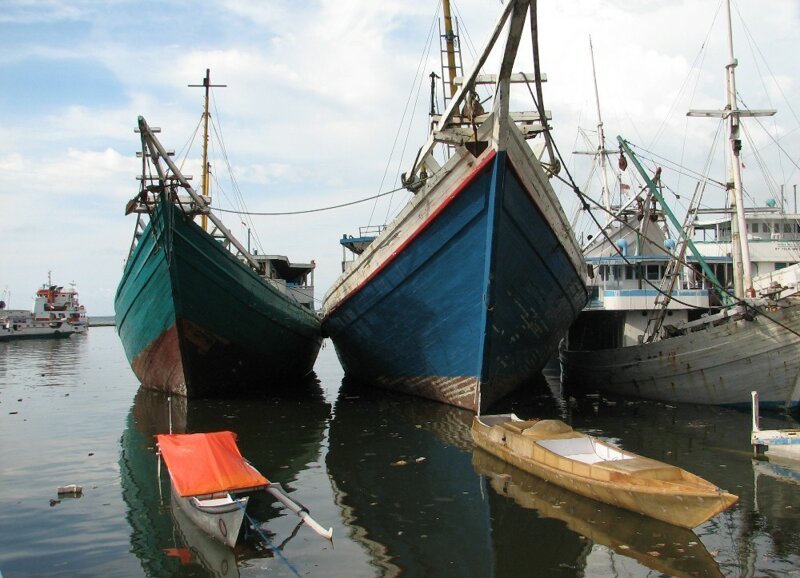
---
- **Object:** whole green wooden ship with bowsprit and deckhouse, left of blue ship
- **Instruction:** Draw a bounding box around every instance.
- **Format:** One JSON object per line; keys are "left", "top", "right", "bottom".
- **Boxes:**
{"left": 114, "top": 83, "right": 322, "bottom": 397}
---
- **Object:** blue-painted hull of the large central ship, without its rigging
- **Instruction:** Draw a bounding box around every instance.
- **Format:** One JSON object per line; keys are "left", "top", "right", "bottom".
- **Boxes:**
{"left": 323, "top": 152, "right": 586, "bottom": 411}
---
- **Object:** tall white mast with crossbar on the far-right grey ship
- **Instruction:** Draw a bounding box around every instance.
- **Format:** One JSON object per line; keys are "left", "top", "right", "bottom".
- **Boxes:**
{"left": 688, "top": 0, "right": 775, "bottom": 299}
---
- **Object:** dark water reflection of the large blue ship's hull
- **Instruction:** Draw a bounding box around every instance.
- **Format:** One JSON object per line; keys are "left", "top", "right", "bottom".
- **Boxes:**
{"left": 327, "top": 379, "right": 585, "bottom": 576}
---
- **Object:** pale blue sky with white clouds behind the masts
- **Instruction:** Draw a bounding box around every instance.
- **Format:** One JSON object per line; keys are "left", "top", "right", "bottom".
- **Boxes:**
{"left": 0, "top": 0, "right": 800, "bottom": 315}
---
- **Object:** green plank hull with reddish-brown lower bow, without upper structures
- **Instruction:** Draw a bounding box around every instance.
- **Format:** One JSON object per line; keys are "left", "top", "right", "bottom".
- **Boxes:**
{"left": 115, "top": 202, "right": 322, "bottom": 397}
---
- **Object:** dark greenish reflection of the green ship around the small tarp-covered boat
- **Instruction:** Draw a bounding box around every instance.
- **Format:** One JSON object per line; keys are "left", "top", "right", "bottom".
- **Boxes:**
{"left": 119, "top": 380, "right": 330, "bottom": 576}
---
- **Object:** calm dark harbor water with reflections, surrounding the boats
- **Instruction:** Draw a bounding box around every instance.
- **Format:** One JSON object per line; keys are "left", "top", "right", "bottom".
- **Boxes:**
{"left": 0, "top": 327, "right": 800, "bottom": 578}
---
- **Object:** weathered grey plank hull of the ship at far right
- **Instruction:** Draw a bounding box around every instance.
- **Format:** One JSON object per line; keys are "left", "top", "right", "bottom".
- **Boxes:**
{"left": 559, "top": 297, "right": 800, "bottom": 409}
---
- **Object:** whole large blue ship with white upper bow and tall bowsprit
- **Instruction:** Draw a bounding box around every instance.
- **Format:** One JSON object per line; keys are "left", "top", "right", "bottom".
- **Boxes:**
{"left": 322, "top": 0, "right": 587, "bottom": 411}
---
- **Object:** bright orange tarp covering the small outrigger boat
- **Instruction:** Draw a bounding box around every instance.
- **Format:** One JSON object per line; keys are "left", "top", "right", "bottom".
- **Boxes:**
{"left": 156, "top": 431, "right": 269, "bottom": 497}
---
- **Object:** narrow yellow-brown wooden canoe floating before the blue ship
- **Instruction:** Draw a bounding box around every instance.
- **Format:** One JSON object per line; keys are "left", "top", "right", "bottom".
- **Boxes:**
{"left": 472, "top": 414, "right": 739, "bottom": 529}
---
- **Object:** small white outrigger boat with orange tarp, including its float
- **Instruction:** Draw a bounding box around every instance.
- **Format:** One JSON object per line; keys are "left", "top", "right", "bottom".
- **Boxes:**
{"left": 156, "top": 431, "right": 333, "bottom": 547}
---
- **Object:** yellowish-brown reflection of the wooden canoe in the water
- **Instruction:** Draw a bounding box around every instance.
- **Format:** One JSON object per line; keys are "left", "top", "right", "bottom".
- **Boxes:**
{"left": 472, "top": 448, "right": 723, "bottom": 577}
